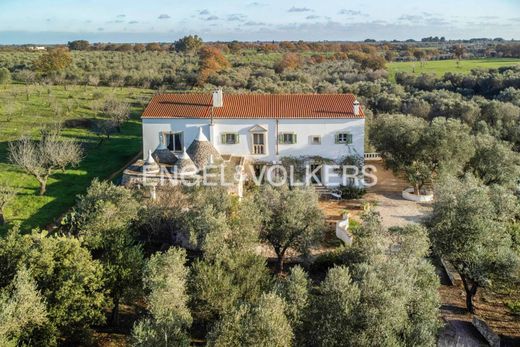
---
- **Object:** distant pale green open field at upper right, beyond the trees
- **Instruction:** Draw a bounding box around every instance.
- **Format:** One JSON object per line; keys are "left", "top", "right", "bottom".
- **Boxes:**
{"left": 387, "top": 58, "right": 520, "bottom": 81}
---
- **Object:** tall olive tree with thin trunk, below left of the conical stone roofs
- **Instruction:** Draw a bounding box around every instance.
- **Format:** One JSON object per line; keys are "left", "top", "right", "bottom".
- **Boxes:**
{"left": 63, "top": 179, "right": 143, "bottom": 326}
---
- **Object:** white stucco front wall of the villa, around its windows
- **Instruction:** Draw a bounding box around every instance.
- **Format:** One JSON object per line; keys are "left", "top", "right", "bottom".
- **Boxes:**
{"left": 143, "top": 118, "right": 365, "bottom": 161}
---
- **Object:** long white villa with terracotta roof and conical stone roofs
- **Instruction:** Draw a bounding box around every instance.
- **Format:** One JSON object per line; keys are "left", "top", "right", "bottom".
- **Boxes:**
{"left": 125, "top": 90, "right": 365, "bottom": 189}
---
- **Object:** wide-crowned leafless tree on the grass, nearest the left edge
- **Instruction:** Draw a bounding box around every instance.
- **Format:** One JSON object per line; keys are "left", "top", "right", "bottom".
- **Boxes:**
{"left": 9, "top": 127, "right": 83, "bottom": 195}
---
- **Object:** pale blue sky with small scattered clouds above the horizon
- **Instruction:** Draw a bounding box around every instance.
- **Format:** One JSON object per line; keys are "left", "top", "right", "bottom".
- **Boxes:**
{"left": 0, "top": 0, "right": 520, "bottom": 44}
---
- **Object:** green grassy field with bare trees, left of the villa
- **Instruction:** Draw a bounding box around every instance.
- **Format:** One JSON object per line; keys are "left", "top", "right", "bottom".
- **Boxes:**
{"left": 0, "top": 85, "right": 151, "bottom": 233}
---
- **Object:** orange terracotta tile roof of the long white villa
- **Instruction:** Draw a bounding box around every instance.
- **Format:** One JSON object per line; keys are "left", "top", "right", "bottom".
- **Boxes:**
{"left": 142, "top": 94, "right": 365, "bottom": 119}
